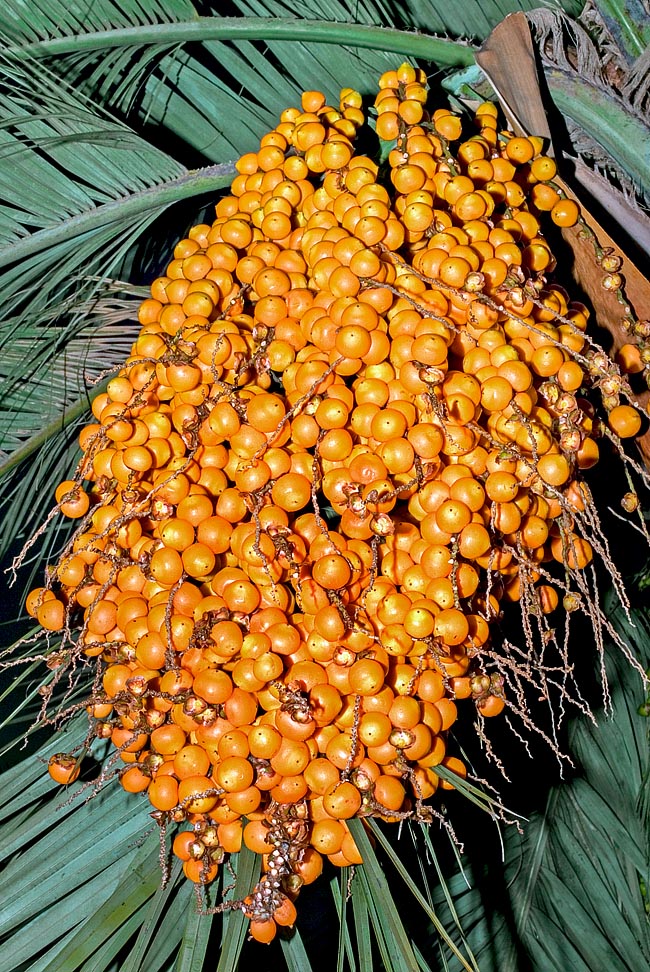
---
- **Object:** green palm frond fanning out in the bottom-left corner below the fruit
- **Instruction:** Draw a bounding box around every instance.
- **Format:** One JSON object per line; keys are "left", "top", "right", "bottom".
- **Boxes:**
{"left": 0, "top": 718, "right": 259, "bottom": 972}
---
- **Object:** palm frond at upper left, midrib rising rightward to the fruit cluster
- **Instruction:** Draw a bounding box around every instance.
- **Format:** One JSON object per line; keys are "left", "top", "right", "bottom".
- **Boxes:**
{"left": 0, "top": 52, "right": 231, "bottom": 464}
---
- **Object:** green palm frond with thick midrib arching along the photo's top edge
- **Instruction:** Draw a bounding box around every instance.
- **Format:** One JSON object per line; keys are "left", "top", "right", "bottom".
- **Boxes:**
{"left": 0, "top": 6, "right": 472, "bottom": 160}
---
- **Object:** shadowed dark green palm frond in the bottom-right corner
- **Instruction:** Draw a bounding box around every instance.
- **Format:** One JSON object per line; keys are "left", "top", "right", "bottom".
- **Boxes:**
{"left": 434, "top": 610, "right": 650, "bottom": 972}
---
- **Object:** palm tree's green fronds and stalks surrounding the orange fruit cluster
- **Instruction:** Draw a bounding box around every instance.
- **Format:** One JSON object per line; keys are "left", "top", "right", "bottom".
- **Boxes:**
{"left": 0, "top": 0, "right": 650, "bottom": 972}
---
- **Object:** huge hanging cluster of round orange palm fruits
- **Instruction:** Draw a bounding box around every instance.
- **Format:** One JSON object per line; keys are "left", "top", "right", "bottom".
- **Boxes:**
{"left": 22, "top": 65, "right": 641, "bottom": 941}
